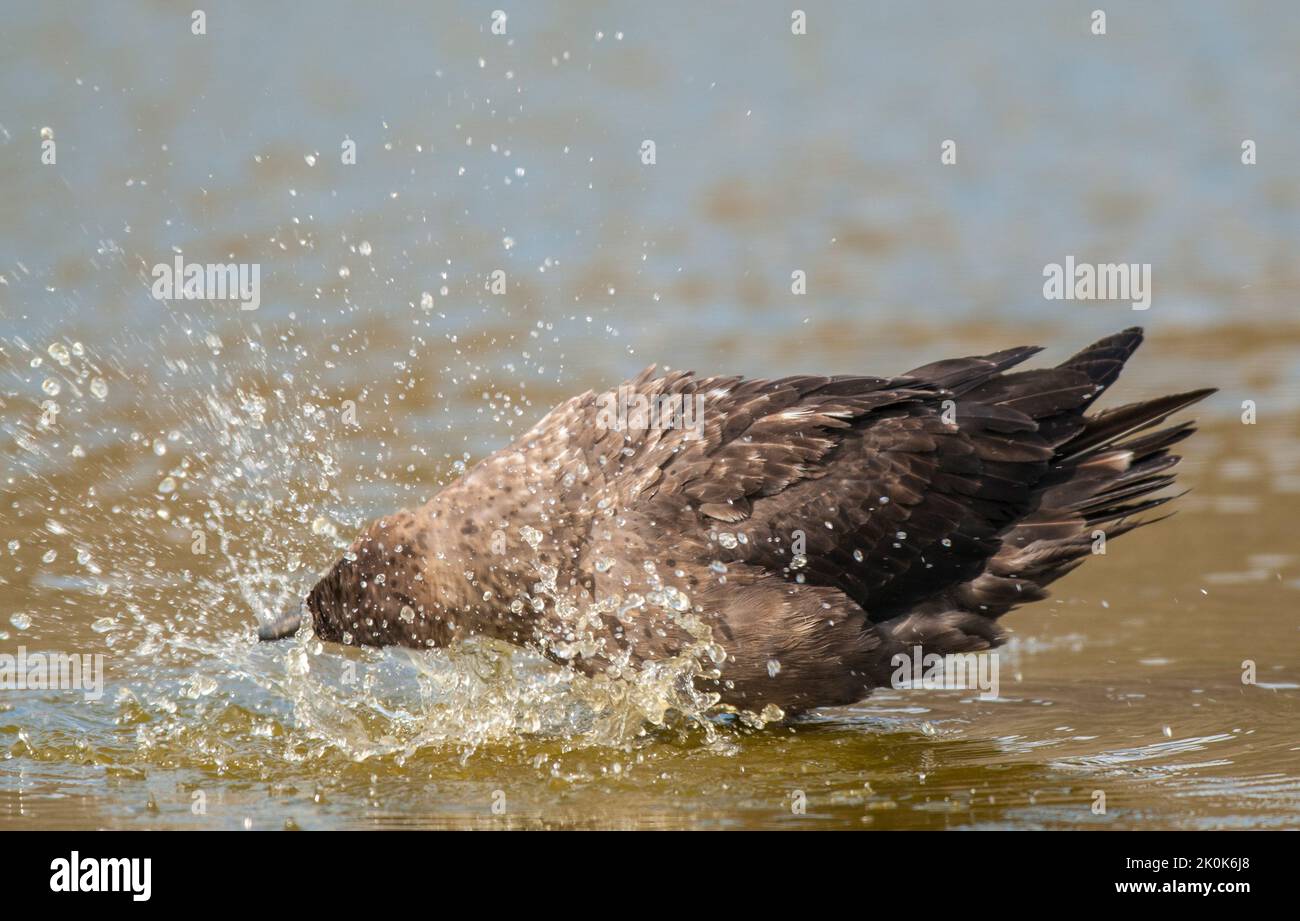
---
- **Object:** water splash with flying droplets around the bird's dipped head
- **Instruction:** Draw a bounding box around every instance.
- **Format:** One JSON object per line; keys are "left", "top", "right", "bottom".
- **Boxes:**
{"left": 0, "top": 333, "right": 743, "bottom": 764}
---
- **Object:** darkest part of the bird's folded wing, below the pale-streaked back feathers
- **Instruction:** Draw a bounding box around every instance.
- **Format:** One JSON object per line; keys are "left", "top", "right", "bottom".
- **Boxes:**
{"left": 660, "top": 382, "right": 1053, "bottom": 621}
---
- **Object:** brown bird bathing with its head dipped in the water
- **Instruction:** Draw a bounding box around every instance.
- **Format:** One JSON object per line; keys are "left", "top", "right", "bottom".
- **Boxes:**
{"left": 259, "top": 328, "right": 1213, "bottom": 713}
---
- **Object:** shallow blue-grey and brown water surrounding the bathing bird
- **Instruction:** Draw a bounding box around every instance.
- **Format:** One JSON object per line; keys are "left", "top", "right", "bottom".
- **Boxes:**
{"left": 0, "top": 4, "right": 1300, "bottom": 829}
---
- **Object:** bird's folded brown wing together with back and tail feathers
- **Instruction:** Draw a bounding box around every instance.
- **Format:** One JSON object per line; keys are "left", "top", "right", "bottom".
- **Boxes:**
{"left": 579, "top": 323, "right": 1204, "bottom": 621}
